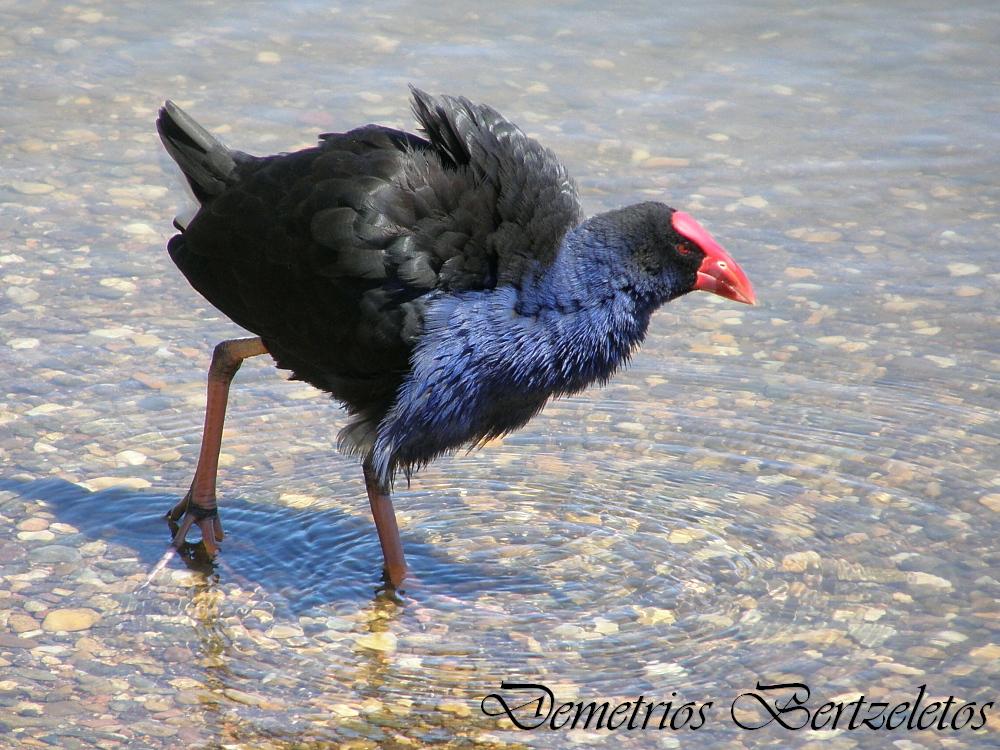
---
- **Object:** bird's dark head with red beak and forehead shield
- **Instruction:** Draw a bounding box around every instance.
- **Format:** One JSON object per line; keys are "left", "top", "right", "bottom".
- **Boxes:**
{"left": 604, "top": 203, "right": 756, "bottom": 305}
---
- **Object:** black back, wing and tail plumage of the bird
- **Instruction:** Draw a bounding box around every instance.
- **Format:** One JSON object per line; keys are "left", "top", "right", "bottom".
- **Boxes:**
{"left": 158, "top": 89, "right": 582, "bottom": 464}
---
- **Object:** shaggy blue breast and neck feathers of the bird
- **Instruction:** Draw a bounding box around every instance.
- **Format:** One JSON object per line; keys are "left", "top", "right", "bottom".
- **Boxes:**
{"left": 372, "top": 256, "right": 652, "bottom": 481}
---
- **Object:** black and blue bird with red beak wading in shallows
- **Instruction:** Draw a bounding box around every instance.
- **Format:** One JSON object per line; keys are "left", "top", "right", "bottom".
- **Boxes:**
{"left": 156, "top": 86, "right": 756, "bottom": 586}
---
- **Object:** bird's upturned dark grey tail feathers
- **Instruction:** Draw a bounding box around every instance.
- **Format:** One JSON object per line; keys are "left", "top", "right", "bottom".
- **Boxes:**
{"left": 156, "top": 100, "right": 242, "bottom": 203}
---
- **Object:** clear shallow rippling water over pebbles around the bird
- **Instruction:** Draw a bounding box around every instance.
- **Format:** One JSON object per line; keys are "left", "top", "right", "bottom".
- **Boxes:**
{"left": 0, "top": 2, "right": 1000, "bottom": 750}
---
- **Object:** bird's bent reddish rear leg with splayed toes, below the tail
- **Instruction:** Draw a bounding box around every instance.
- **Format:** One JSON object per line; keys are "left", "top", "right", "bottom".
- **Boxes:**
{"left": 166, "top": 338, "right": 267, "bottom": 557}
